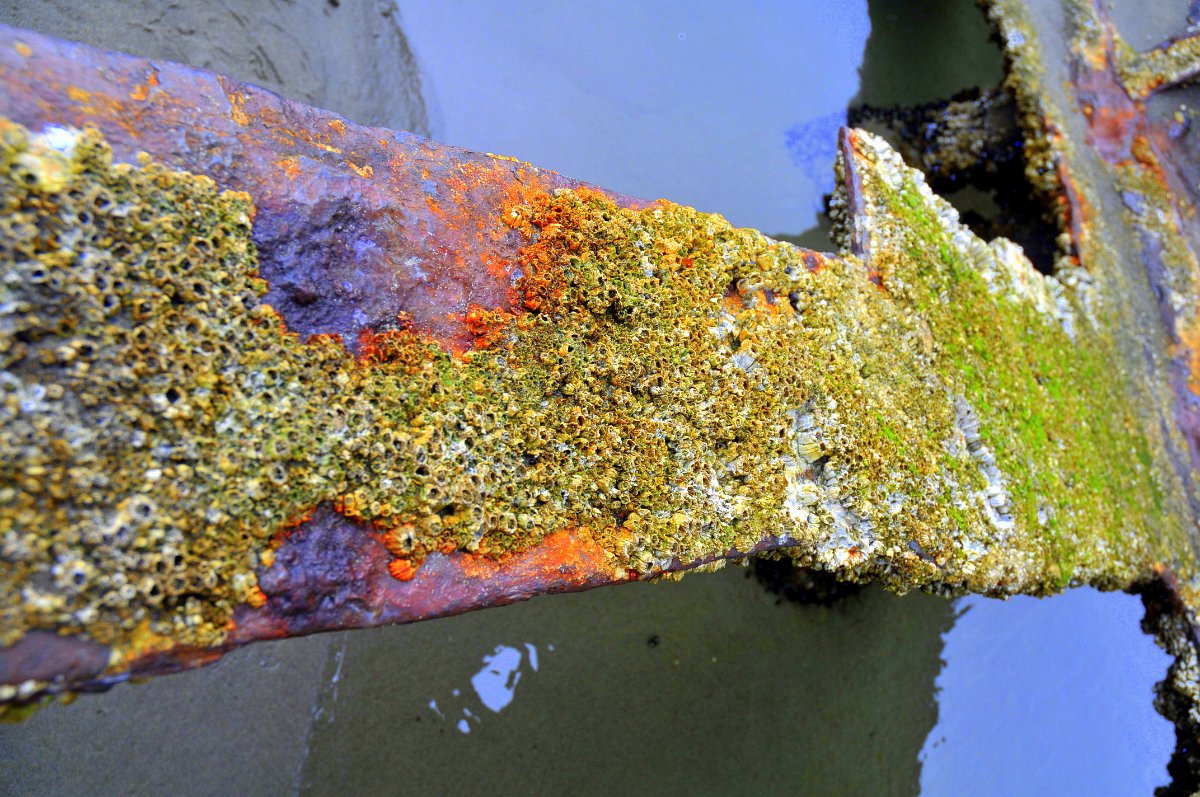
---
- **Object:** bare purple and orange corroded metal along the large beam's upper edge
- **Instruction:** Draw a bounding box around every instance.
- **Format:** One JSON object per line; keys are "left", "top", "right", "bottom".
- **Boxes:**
{"left": 0, "top": 26, "right": 644, "bottom": 350}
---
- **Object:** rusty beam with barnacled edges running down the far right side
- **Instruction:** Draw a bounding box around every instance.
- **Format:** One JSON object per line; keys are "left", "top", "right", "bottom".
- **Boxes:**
{"left": 985, "top": 0, "right": 1200, "bottom": 793}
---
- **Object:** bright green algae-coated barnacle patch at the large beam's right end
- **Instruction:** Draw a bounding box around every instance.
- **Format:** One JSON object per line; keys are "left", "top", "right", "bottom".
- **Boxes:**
{"left": 844, "top": 130, "right": 1189, "bottom": 587}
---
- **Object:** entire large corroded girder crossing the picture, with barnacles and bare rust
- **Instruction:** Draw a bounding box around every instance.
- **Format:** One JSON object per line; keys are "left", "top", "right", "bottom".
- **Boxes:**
{"left": 0, "top": 12, "right": 1196, "bottom": 720}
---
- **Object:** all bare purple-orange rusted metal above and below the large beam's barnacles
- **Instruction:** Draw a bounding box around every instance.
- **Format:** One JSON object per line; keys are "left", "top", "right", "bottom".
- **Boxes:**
{"left": 0, "top": 23, "right": 835, "bottom": 699}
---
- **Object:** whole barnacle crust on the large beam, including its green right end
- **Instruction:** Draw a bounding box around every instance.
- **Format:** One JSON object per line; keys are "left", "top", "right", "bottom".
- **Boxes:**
{"left": 0, "top": 115, "right": 1190, "bottom": 667}
